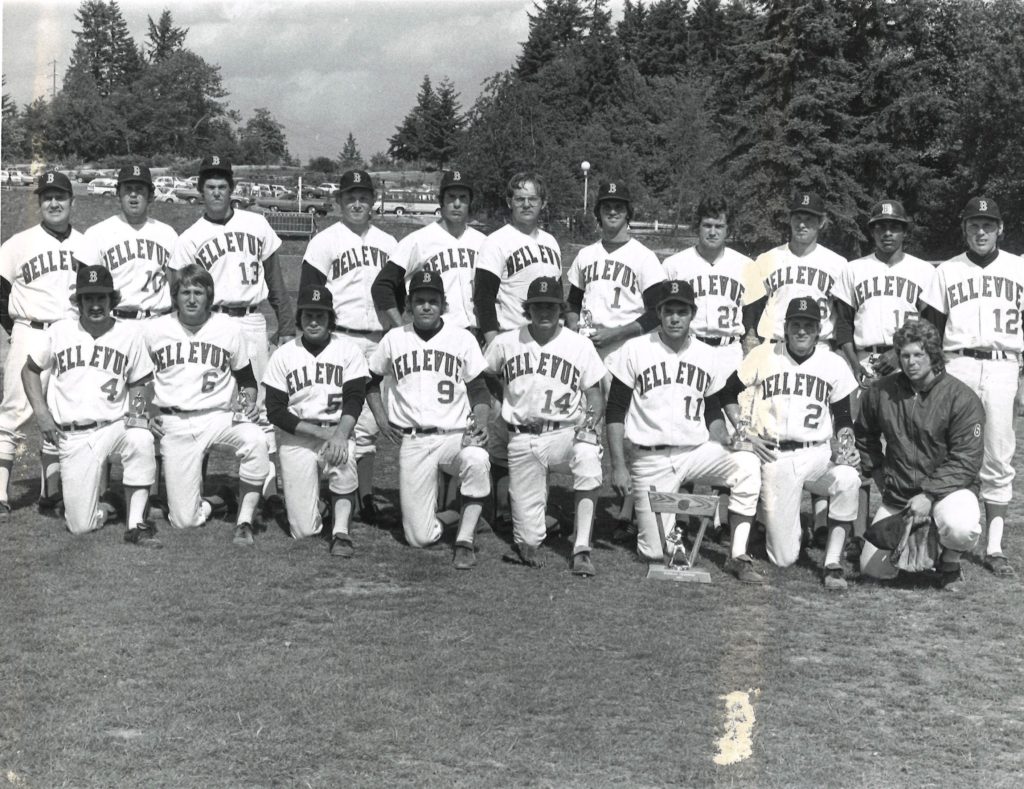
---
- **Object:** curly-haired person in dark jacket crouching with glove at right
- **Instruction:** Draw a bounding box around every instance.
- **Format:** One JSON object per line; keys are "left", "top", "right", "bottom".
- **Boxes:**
{"left": 854, "top": 320, "right": 985, "bottom": 588}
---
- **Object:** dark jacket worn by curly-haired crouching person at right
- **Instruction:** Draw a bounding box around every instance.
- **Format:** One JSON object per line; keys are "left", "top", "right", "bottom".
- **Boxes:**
{"left": 854, "top": 372, "right": 985, "bottom": 507}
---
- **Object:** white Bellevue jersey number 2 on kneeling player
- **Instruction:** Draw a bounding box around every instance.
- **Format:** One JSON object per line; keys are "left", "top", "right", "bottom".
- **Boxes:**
{"left": 736, "top": 343, "right": 857, "bottom": 442}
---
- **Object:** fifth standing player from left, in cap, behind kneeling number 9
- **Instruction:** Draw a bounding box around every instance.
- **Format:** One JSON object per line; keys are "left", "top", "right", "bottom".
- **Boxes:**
{"left": 371, "top": 170, "right": 486, "bottom": 330}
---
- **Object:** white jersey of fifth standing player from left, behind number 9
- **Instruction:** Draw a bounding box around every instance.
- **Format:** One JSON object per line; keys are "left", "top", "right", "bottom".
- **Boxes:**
{"left": 391, "top": 222, "right": 487, "bottom": 328}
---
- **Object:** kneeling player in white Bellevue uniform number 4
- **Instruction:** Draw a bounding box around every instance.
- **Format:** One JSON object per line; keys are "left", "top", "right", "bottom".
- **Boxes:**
{"left": 22, "top": 266, "right": 160, "bottom": 547}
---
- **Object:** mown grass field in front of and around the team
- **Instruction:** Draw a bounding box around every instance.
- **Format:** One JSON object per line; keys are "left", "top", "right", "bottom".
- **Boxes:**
{"left": 0, "top": 193, "right": 1024, "bottom": 787}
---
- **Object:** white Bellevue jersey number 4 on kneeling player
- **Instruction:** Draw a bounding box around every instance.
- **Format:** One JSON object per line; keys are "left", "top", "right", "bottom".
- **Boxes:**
{"left": 32, "top": 318, "right": 153, "bottom": 425}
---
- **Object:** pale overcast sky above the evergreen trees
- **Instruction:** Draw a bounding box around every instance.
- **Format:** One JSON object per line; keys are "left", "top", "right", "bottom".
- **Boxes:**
{"left": 2, "top": 0, "right": 622, "bottom": 163}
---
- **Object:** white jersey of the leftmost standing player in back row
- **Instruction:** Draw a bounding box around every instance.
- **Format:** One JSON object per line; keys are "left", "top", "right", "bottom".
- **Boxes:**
{"left": 0, "top": 225, "right": 99, "bottom": 323}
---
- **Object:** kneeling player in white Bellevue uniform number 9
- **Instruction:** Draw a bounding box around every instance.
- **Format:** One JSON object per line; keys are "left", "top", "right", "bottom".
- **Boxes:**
{"left": 367, "top": 269, "right": 490, "bottom": 570}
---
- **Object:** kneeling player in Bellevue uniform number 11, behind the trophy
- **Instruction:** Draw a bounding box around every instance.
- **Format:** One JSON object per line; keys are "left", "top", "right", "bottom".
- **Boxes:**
{"left": 606, "top": 279, "right": 765, "bottom": 583}
